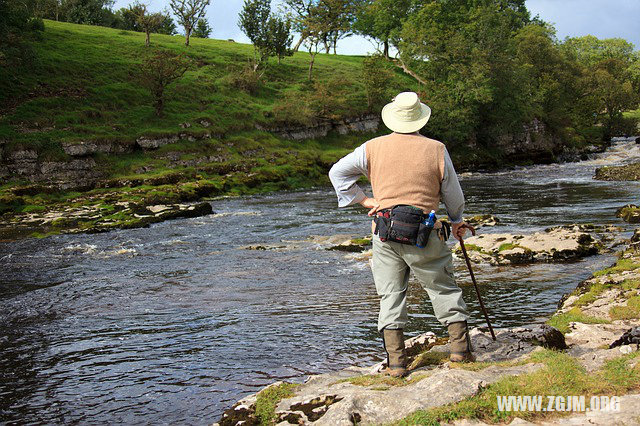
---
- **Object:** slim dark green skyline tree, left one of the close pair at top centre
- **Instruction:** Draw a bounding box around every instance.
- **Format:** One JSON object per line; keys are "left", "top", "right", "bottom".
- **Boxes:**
{"left": 238, "top": 0, "right": 271, "bottom": 71}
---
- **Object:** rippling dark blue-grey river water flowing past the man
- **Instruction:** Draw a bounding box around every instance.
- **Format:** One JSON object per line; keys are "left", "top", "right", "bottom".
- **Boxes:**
{"left": 0, "top": 141, "right": 640, "bottom": 424}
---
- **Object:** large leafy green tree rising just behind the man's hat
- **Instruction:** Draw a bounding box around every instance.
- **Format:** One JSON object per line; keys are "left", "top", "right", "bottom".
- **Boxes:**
{"left": 392, "top": 0, "right": 530, "bottom": 143}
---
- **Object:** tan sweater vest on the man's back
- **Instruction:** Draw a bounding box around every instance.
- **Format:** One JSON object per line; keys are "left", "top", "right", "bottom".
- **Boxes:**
{"left": 365, "top": 133, "right": 445, "bottom": 213}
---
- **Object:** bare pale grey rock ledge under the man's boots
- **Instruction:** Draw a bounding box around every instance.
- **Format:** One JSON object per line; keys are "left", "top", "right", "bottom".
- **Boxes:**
{"left": 218, "top": 325, "right": 567, "bottom": 426}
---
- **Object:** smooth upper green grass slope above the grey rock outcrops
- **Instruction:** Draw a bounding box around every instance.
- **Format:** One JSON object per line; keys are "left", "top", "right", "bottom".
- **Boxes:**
{"left": 0, "top": 21, "right": 412, "bottom": 156}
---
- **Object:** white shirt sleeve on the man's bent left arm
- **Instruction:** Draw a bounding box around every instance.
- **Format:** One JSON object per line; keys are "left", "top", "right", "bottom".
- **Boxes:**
{"left": 329, "top": 142, "right": 369, "bottom": 207}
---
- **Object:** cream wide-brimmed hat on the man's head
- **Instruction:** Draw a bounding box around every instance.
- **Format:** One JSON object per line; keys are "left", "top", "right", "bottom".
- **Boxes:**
{"left": 382, "top": 92, "right": 431, "bottom": 133}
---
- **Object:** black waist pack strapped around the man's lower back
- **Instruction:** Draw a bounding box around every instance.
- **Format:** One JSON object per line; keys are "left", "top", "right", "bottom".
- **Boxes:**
{"left": 373, "top": 204, "right": 436, "bottom": 248}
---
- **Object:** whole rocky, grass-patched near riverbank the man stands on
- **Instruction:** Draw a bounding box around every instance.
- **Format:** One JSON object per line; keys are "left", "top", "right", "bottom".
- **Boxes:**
{"left": 219, "top": 229, "right": 640, "bottom": 425}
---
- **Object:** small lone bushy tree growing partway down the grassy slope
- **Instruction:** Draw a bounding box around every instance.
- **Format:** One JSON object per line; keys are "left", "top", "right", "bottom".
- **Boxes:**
{"left": 140, "top": 50, "right": 191, "bottom": 117}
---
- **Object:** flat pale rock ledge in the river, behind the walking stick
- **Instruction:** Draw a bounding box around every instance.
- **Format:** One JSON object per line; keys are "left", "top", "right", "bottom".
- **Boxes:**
{"left": 455, "top": 224, "right": 623, "bottom": 265}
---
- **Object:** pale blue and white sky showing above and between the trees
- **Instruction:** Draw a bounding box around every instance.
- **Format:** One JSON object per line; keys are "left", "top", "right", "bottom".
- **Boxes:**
{"left": 114, "top": 0, "right": 640, "bottom": 55}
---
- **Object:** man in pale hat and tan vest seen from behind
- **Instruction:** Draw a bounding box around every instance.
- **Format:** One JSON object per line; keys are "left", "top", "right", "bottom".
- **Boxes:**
{"left": 329, "top": 92, "right": 475, "bottom": 377}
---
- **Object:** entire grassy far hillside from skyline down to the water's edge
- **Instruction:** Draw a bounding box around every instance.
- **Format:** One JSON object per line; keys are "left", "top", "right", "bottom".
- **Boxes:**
{"left": 0, "top": 21, "right": 424, "bottom": 236}
